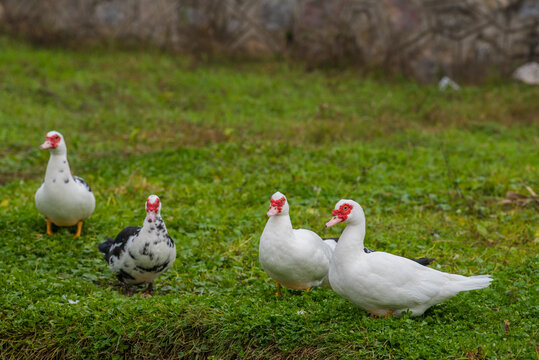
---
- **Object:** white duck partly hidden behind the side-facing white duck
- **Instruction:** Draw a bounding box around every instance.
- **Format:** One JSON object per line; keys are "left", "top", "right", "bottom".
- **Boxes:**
{"left": 258, "top": 192, "right": 337, "bottom": 296}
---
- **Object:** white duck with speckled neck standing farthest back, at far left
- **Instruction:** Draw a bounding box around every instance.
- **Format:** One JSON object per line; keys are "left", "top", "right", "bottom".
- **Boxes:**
{"left": 35, "top": 131, "right": 95, "bottom": 237}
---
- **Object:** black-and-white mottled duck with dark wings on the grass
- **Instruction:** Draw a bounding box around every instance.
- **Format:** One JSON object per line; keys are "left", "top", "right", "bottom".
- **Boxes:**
{"left": 99, "top": 195, "right": 176, "bottom": 295}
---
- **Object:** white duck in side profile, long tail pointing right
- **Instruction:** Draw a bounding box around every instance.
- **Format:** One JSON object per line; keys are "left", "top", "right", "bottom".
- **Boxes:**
{"left": 326, "top": 200, "right": 492, "bottom": 316}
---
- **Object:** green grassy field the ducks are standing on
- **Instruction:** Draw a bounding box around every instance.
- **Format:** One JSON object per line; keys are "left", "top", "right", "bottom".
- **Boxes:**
{"left": 0, "top": 38, "right": 539, "bottom": 359}
